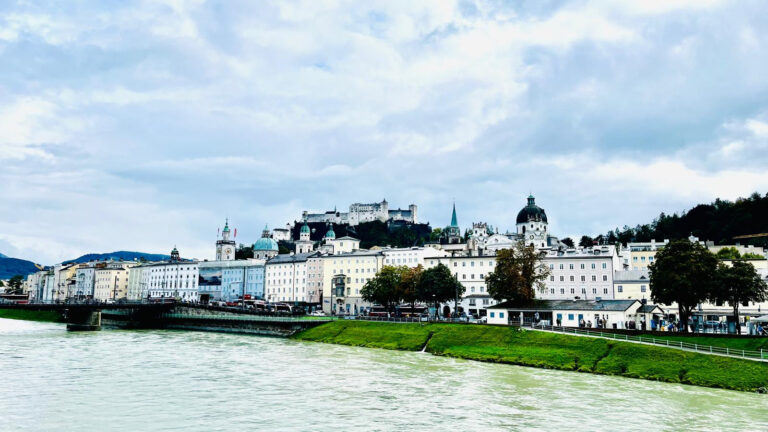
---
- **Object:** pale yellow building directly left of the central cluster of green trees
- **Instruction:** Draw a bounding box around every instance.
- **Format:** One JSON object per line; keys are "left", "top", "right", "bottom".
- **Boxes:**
{"left": 322, "top": 251, "right": 384, "bottom": 314}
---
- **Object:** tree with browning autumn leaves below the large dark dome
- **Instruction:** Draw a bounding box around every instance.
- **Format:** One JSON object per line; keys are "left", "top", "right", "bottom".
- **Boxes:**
{"left": 485, "top": 242, "right": 549, "bottom": 305}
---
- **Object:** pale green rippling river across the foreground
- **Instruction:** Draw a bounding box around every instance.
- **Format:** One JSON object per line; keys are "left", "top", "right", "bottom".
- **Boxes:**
{"left": 0, "top": 319, "right": 768, "bottom": 432}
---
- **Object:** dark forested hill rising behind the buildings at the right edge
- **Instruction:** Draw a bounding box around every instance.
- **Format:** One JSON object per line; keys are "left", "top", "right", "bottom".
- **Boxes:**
{"left": 595, "top": 193, "right": 768, "bottom": 246}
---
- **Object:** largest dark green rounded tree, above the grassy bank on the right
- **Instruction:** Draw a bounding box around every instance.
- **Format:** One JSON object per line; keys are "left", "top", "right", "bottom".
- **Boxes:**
{"left": 648, "top": 239, "right": 718, "bottom": 332}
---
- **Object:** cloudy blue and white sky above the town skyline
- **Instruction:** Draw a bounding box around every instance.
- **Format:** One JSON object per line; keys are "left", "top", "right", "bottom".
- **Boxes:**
{"left": 0, "top": 0, "right": 768, "bottom": 264}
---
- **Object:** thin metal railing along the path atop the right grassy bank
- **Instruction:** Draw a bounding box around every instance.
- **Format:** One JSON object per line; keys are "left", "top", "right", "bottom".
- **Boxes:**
{"left": 531, "top": 324, "right": 768, "bottom": 361}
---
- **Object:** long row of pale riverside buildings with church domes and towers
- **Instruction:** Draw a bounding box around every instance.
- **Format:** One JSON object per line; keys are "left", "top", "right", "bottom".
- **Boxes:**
{"left": 19, "top": 196, "right": 768, "bottom": 316}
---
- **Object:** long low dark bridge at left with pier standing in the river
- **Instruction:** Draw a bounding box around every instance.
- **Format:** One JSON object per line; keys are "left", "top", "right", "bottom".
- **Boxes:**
{"left": 0, "top": 303, "right": 331, "bottom": 336}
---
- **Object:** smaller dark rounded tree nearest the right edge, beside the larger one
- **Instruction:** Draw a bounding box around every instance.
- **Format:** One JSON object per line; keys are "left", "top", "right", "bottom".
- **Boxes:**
{"left": 712, "top": 260, "right": 768, "bottom": 334}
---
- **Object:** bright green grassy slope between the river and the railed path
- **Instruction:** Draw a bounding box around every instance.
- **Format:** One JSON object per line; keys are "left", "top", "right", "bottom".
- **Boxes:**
{"left": 294, "top": 321, "right": 768, "bottom": 391}
